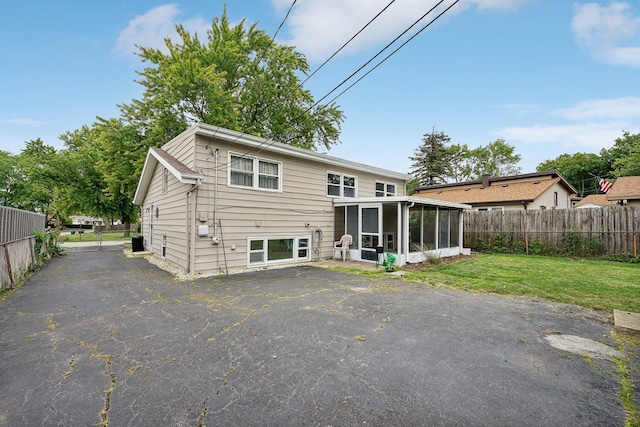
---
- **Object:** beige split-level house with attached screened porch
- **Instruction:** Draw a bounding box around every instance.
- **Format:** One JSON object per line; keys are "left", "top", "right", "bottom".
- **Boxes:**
{"left": 134, "top": 124, "right": 469, "bottom": 274}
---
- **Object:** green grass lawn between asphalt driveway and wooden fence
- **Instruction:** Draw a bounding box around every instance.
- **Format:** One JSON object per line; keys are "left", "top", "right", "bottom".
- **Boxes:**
{"left": 364, "top": 254, "right": 640, "bottom": 313}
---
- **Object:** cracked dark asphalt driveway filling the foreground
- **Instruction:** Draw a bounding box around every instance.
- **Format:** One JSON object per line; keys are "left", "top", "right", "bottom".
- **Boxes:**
{"left": 0, "top": 251, "right": 624, "bottom": 426}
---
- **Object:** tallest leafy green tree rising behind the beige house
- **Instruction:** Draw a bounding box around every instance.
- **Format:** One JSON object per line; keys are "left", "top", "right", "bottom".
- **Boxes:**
{"left": 120, "top": 9, "right": 344, "bottom": 149}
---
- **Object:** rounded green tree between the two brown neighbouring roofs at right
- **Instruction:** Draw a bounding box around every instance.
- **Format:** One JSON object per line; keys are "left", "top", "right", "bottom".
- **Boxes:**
{"left": 536, "top": 153, "right": 610, "bottom": 197}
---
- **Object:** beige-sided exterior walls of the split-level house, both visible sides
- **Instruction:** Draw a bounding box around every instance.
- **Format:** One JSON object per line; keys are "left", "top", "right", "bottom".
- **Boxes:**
{"left": 142, "top": 134, "right": 405, "bottom": 274}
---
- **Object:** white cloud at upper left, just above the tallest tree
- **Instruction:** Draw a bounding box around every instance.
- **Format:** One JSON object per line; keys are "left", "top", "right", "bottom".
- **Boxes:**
{"left": 114, "top": 4, "right": 211, "bottom": 55}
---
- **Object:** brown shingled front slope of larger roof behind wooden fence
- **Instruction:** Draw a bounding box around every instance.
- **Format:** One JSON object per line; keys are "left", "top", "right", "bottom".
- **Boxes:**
{"left": 415, "top": 178, "right": 560, "bottom": 204}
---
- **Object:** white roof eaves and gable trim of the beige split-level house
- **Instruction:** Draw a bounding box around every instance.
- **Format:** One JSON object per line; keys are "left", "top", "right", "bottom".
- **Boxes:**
{"left": 133, "top": 123, "right": 411, "bottom": 205}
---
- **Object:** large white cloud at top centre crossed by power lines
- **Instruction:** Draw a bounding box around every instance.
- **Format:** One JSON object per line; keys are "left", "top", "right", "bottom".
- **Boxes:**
{"left": 272, "top": 0, "right": 531, "bottom": 60}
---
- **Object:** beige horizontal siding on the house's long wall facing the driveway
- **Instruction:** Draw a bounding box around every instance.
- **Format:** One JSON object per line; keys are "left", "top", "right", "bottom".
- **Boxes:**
{"left": 189, "top": 138, "right": 405, "bottom": 273}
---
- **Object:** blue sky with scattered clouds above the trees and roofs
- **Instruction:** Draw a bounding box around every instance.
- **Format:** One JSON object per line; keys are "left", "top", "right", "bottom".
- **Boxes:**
{"left": 0, "top": 0, "right": 640, "bottom": 173}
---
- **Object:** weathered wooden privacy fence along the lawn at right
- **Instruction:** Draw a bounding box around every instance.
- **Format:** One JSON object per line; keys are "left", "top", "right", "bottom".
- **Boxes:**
{"left": 464, "top": 206, "right": 640, "bottom": 257}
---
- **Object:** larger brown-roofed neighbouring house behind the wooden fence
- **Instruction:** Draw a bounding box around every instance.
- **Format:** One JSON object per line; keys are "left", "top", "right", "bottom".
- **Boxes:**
{"left": 415, "top": 171, "right": 577, "bottom": 211}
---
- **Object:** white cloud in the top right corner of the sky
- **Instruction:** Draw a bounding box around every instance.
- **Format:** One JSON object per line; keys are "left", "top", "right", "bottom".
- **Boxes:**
{"left": 571, "top": 2, "right": 640, "bottom": 67}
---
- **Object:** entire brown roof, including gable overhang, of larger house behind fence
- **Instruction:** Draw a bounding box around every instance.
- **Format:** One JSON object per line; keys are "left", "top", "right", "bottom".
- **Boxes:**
{"left": 416, "top": 171, "right": 577, "bottom": 204}
